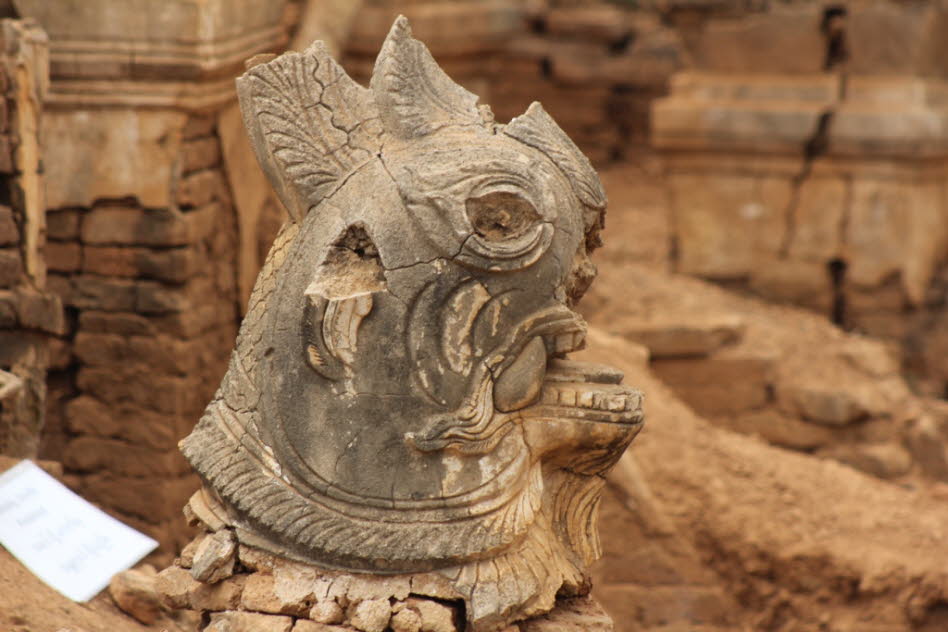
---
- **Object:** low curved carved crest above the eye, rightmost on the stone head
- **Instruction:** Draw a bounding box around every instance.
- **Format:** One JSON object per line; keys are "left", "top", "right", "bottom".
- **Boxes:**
{"left": 504, "top": 101, "right": 606, "bottom": 209}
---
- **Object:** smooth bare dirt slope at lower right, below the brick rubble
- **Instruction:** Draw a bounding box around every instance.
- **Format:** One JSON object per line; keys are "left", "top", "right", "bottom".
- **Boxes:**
{"left": 584, "top": 329, "right": 948, "bottom": 632}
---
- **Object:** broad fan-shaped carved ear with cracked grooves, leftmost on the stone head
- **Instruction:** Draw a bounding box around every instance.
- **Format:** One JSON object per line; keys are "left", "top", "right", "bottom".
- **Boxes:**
{"left": 237, "top": 42, "right": 381, "bottom": 221}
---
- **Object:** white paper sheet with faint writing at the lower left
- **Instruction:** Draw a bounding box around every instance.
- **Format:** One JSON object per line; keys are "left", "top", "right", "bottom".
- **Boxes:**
{"left": 0, "top": 461, "right": 158, "bottom": 601}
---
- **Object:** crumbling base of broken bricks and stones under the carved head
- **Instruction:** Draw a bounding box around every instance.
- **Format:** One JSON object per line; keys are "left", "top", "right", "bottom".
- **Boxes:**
{"left": 155, "top": 493, "right": 613, "bottom": 632}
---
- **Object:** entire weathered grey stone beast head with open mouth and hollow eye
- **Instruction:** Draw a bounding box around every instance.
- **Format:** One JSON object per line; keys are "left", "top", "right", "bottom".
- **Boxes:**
{"left": 182, "top": 18, "right": 642, "bottom": 630}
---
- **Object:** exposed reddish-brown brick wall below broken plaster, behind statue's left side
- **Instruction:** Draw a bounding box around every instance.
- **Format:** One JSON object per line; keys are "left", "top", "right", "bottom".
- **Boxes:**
{"left": 44, "top": 116, "right": 238, "bottom": 550}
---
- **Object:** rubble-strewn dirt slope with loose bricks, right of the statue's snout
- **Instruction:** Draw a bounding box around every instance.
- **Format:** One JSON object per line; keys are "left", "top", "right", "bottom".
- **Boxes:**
{"left": 580, "top": 212, "right": 948, "bottom": 481}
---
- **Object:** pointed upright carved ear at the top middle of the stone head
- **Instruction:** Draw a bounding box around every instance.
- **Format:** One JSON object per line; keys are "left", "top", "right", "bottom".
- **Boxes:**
{"left": 370, "top": 15, "right": 483, "bottom": 140}
